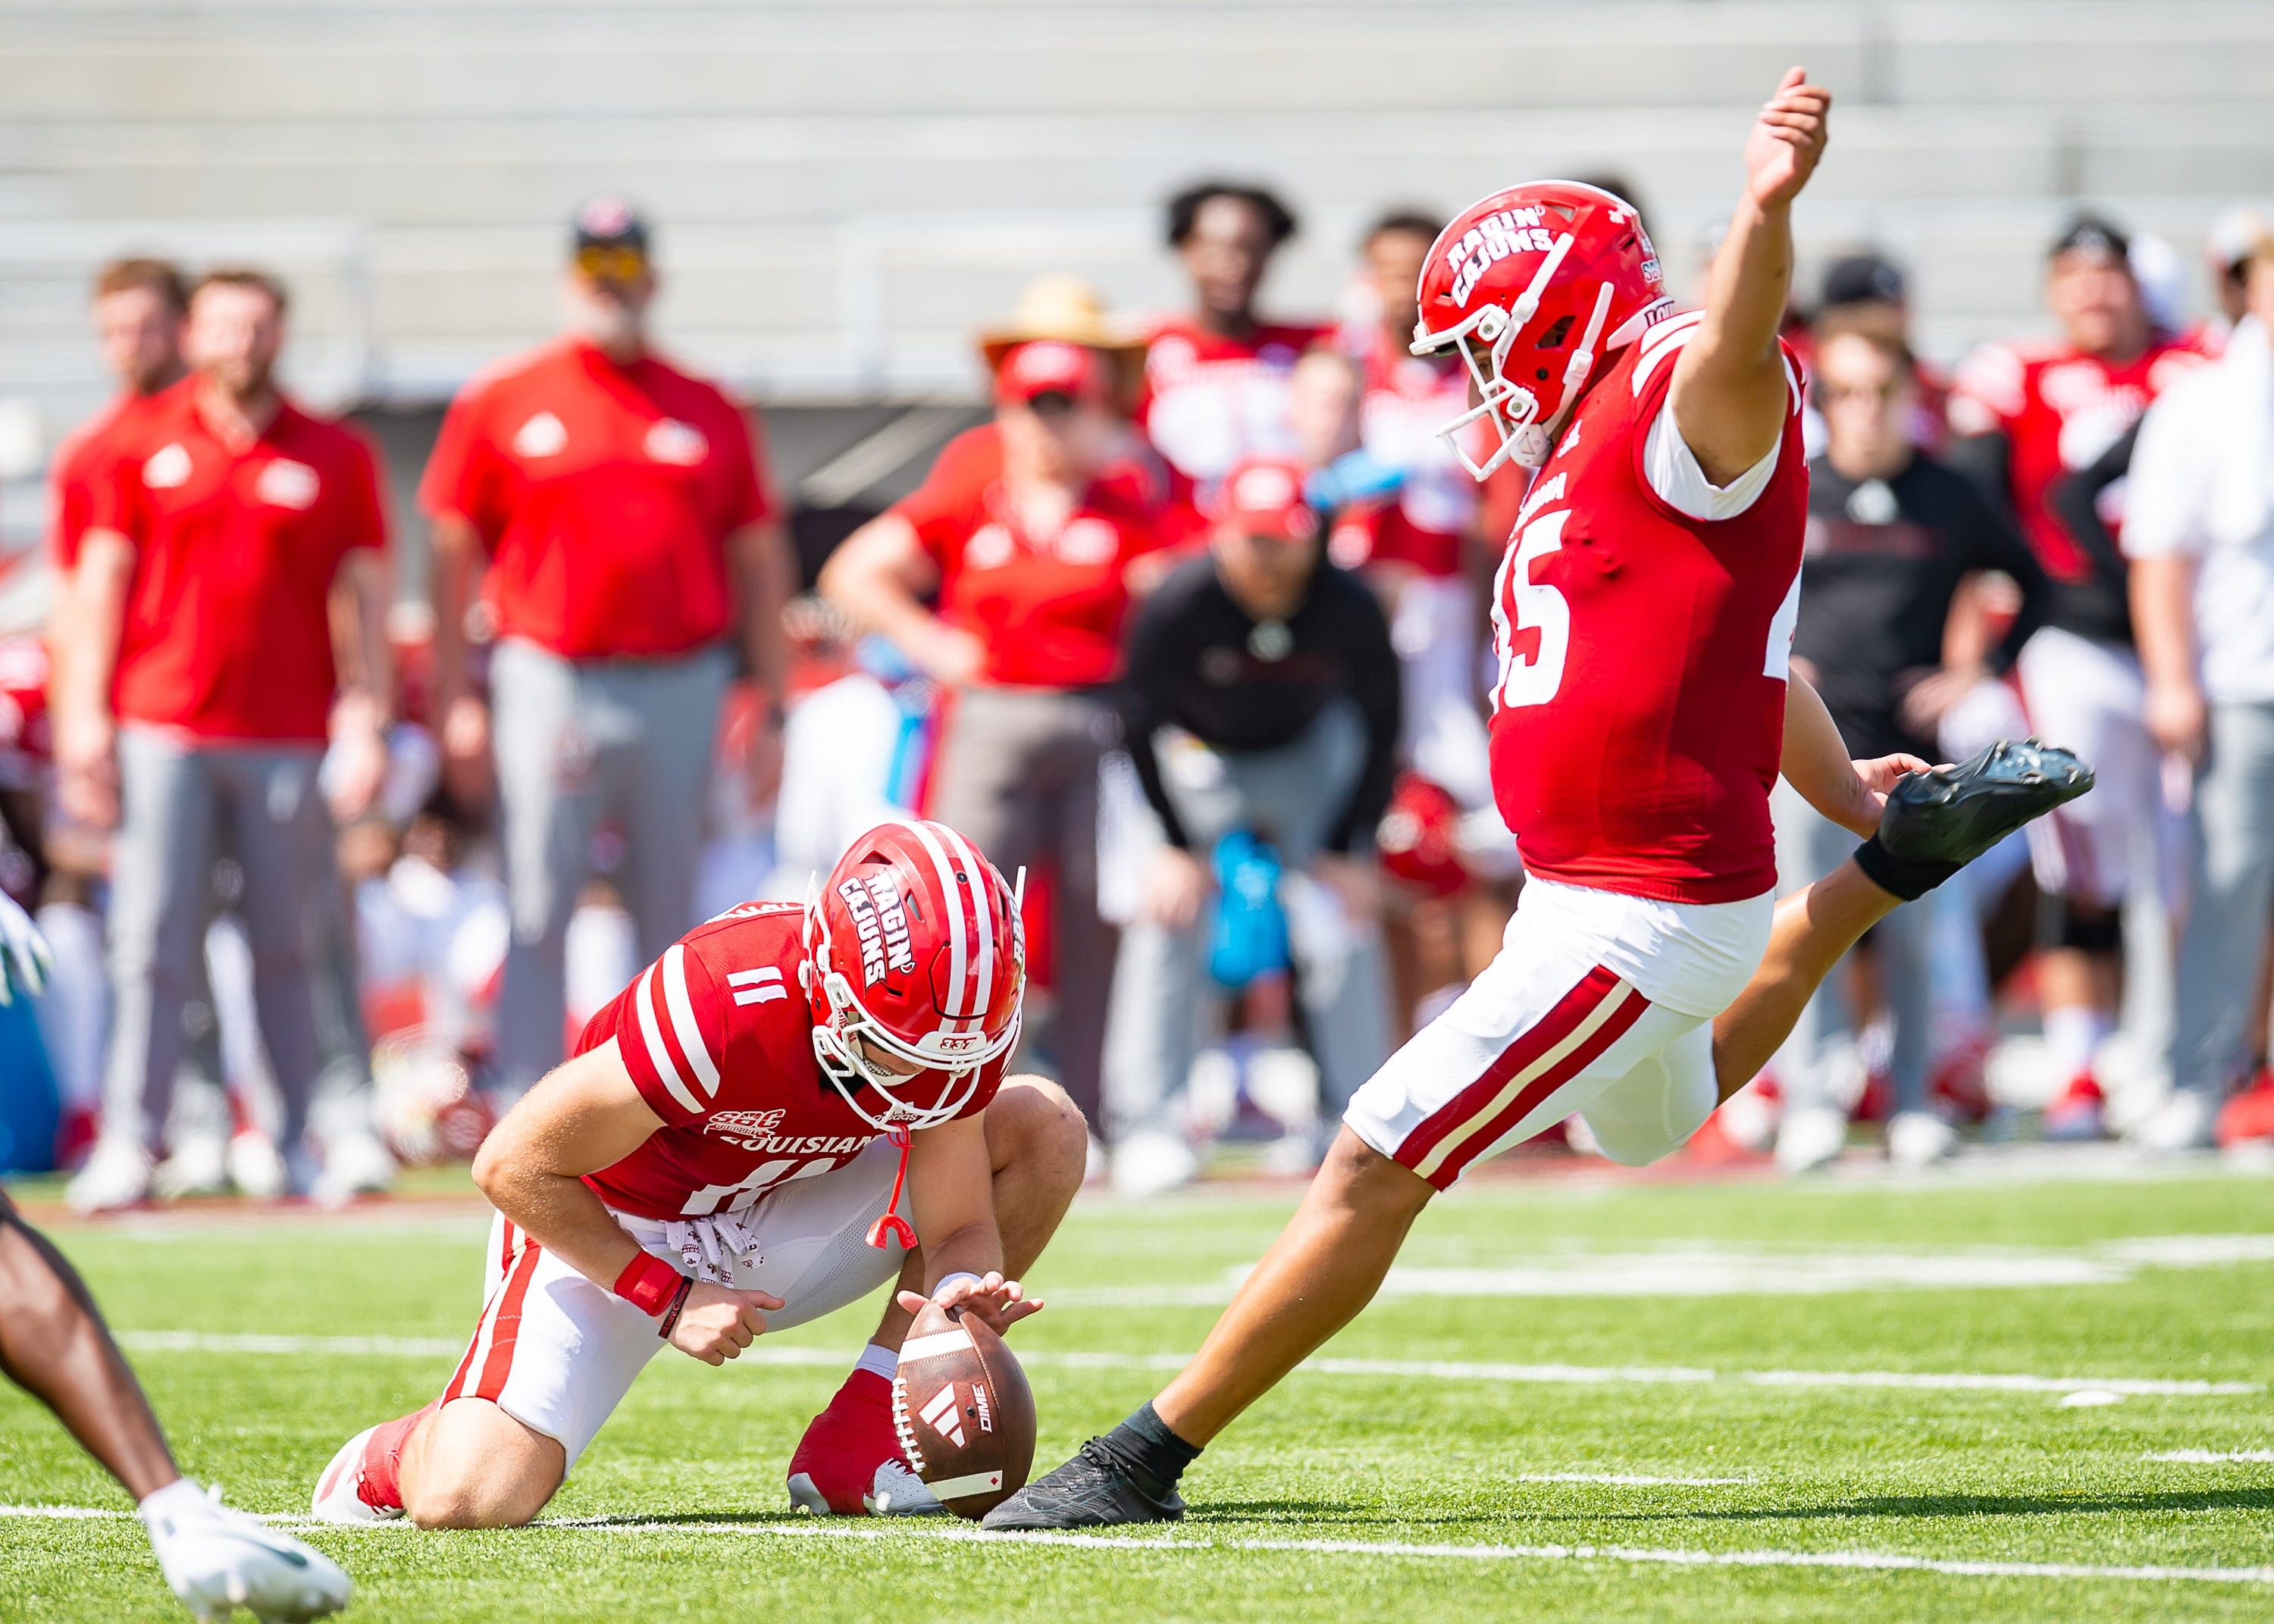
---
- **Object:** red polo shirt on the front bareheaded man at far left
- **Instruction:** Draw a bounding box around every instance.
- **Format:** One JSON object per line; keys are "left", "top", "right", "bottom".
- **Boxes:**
{"left": 89, "top": 377, "right": 387, "bottom": 743}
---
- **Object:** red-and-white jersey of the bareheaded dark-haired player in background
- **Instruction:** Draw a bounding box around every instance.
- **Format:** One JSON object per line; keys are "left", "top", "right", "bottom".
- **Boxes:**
{"left": 1137, "top": 316, "right": 1333, "bottom": 493}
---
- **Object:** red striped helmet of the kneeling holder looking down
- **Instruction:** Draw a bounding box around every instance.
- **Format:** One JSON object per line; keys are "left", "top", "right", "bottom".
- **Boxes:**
{"left": 805, "top": 819, "right": 1026, "bottom": 1131}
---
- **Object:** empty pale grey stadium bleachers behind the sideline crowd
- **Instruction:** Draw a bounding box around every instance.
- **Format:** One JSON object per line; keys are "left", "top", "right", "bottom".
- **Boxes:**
{"left": 0, "top": 0, "right": 2274, "bottom": 439}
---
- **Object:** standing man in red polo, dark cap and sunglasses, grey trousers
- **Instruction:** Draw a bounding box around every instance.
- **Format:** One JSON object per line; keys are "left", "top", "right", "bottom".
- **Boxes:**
{"left": 421, "top": 198, "right": 791, "bottom": 1094}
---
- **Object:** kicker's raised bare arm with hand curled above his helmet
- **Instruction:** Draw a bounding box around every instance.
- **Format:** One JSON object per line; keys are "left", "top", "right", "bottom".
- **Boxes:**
{"left": 1667, "top": 68, "right": 1833, "bottom": 484}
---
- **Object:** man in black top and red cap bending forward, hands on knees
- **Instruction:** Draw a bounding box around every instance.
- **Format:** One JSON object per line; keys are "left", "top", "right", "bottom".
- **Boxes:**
{"left": 1105, "top": 459, "right": 1401, "bottom": 1190}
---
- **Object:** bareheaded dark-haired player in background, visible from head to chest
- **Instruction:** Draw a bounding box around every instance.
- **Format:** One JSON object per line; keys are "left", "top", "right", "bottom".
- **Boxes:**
{"left": 1137, "top": 180, "right": 1328, "bottom": 500}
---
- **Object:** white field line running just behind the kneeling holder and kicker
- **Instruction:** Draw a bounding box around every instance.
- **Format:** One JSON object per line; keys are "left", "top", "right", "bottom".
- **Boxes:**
{"left": 118, "top": 1331, "right": 2267, "bottom": 1399}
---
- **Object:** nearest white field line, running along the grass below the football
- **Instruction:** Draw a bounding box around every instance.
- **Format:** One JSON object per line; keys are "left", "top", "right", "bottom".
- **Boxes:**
{"left": 0, "top": 1506, "right": 2274, "bottom": 1585}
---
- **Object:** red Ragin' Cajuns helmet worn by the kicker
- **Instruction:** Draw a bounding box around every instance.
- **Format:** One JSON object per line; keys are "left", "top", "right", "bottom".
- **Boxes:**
{"left": 1412, "top": 180, "right": 1674, "bottom": 480}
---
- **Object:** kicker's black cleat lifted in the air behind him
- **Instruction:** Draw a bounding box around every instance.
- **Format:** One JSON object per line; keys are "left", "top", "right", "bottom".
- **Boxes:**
{"left": 1856, "top": 739, "right": 2092, "bottom": 896}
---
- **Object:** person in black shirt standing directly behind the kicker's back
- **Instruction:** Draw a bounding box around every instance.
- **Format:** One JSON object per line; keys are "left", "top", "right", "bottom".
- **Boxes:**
{"left": 1778, "top": 325, "right": 2049, "bottom": 1169}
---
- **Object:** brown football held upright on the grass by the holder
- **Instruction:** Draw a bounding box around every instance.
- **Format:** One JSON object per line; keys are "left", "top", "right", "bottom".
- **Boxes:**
{"left": 891, "top": 1303, "right": 1035, "bottom": 1522}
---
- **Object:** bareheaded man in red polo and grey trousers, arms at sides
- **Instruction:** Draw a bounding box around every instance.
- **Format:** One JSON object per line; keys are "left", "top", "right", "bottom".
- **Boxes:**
{"left": 55, "top": 271, "right": 393, "bottom": 1210}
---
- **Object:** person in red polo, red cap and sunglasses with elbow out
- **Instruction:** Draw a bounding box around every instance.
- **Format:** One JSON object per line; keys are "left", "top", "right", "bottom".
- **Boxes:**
{"left": 821, "top": 296, "right": 1162, "bottom": 1122}
